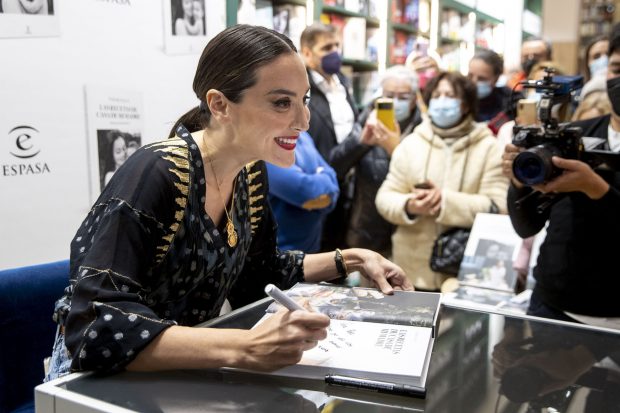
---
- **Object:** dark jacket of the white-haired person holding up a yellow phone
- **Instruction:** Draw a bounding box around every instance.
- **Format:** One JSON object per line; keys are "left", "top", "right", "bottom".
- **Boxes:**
{"left": 330, "top": 106, "right": 422, "bottom": 252}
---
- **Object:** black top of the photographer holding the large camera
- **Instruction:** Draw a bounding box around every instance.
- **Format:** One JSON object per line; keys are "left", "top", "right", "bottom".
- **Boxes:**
{"left": 508, "top": 115, "right": 620, "bottom": 317}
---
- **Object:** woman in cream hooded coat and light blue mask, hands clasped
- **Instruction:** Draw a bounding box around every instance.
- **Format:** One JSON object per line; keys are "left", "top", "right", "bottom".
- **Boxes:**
{"left": 375, "top": 72, "right": 508, "bottom": 291}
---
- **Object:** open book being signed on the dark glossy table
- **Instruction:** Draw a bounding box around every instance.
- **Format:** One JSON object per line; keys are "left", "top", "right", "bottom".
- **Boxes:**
{"left": 228, "top": 283, "right": 441, "bottom": 388}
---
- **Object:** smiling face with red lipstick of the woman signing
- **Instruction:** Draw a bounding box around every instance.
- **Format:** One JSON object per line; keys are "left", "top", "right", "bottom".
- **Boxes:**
{"left": 225, "top": 53, "right": 310, "bottom": 167}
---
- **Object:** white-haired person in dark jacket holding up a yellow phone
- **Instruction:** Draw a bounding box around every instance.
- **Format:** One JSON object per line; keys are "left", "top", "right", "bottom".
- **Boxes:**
{"left": 331, "top": 65, "right": 422, "bottom": 256}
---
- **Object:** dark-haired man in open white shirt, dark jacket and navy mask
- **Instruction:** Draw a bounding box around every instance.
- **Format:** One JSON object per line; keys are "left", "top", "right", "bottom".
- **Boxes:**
{"left": 300, "top": 23, "right": 362, "bottom": 251}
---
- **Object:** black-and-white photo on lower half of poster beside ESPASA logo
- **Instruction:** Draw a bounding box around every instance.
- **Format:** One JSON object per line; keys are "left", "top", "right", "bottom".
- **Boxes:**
{"left": 97, "top": 129, "right": 142, "bottom": 190}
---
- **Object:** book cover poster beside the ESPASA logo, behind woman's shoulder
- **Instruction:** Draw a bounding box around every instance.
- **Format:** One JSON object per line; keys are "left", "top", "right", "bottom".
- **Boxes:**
{"left": 86, "top": 85, "right": 144, "bottom": 203}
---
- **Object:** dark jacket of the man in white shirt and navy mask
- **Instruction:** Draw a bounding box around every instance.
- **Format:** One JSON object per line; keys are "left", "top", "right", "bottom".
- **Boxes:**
{"left": 308, "top": 72, "right": 362, "bottom": 251}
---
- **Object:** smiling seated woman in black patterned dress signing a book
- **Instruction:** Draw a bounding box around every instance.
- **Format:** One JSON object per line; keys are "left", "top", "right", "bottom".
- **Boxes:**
{"left": 48, "top": 25, "right": 412, "bottom": 379}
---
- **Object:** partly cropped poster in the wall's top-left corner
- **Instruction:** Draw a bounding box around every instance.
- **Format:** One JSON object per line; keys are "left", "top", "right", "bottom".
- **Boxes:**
{"left": 0, "top": 0, "right": 60, "bottom": 38}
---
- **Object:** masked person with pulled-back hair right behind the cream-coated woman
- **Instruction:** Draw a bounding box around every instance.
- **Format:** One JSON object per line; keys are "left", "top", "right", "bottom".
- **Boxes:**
{"left": 467, "top": 50, "right": 523, "bottom": 135}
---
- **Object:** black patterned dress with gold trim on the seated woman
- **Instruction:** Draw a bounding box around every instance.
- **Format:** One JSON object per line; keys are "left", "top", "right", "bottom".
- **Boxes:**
{"left": 50, "top": 126, "right": 304, "bottom": 372}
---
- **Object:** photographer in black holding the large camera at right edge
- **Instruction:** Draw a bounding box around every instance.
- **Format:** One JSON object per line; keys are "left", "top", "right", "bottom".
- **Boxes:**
{"left": 502, "top": 31, "right": 620, "bottom": 324}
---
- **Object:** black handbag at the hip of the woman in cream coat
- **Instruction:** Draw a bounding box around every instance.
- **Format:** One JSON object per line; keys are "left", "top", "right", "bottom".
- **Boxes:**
{"left": 430, "top": 228, "right": 471, "bottom": 275}
